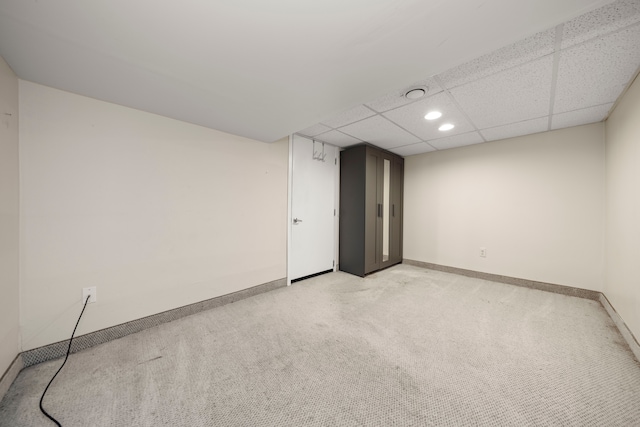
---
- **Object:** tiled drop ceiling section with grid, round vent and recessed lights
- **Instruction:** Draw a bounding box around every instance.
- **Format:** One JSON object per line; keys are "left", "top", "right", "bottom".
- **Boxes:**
{"left": 297, "top": 0, "right": 640, "bottom": 156}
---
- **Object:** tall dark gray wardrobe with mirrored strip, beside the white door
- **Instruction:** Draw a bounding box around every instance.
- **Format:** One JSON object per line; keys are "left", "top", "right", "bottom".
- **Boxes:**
{"left": 339, "top": 145, "right": 404, "bottom": 277}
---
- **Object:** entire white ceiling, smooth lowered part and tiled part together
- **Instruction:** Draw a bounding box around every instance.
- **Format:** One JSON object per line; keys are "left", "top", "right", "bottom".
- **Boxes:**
{"left": 0, "top": 0, "right": 638, "bottom": 150}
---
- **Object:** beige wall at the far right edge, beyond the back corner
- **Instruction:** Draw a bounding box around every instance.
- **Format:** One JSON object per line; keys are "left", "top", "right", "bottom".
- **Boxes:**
{"left": 605, "top": 73, "right": 640, "bottom": 339}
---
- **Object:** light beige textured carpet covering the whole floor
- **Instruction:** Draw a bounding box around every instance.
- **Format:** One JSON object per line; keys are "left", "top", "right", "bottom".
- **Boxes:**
{"left": 0, "top": 265, "right": 640, "bottom": 427}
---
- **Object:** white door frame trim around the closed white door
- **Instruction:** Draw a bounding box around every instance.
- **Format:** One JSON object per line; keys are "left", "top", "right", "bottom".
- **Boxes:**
{"left": 287, "top": 135, "right": 342, "bottom": 286}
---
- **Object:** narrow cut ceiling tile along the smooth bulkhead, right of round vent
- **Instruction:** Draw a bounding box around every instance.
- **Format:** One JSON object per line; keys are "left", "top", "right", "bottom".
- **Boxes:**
{"left": 438, "top": 29, "right": 555, "bottom": 89}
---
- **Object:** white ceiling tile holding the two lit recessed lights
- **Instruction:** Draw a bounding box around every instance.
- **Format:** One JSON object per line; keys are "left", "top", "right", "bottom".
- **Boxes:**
{"left": 384, "top": 92, "right": 474, "bottom": 141}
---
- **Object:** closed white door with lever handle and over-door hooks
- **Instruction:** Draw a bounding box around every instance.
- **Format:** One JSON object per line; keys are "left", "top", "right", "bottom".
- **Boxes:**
{"left": 289, "top": 135, "right": 338, "bottom": 280}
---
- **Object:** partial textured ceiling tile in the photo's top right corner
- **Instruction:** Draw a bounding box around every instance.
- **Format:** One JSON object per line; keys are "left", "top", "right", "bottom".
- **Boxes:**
{"left": 562, "top": 0, "right": 640, "bottom": 49}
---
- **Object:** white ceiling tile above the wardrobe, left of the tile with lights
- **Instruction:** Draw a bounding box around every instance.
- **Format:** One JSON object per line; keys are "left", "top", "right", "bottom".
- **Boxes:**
{"left": 340, "top": 116, "right": 420, "bottom": 148}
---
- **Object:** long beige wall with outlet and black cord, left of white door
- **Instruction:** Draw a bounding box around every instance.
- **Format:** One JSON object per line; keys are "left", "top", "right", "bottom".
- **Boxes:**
{"left": 20, "top": 81, "right": 288, "bottom": 350}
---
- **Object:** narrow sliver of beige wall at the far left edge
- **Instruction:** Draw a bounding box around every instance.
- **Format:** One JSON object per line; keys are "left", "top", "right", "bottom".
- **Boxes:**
{"left": 0, "top": 57, "right": 20, "bottom": 377}
